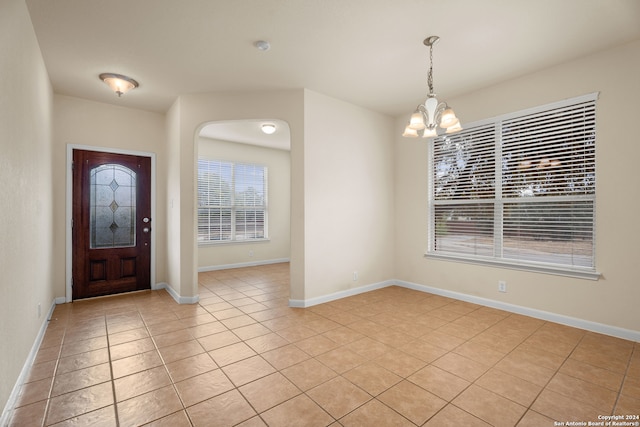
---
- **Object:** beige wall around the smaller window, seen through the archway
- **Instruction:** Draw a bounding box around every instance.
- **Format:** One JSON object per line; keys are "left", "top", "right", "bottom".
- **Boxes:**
{"left": 198, "top": 137, "right": 291, "bottom": 269}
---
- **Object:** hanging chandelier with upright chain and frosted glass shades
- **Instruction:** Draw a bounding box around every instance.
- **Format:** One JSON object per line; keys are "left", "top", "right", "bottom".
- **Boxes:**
{"left": 402, "top": 36, "right": 462, "bottom": 138}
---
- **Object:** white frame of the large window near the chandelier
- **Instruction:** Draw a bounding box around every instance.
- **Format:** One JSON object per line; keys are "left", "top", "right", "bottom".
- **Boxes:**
{"left": 424, "top": 92, "right": 600, "bottom": 280}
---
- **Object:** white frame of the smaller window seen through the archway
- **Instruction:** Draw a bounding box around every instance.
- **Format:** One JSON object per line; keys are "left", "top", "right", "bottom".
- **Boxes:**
{"left": 196, "top": 157, "right": 270, "bottom": 246}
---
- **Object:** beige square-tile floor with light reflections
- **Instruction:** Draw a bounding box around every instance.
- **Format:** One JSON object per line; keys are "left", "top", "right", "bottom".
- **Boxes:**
{"left": 6, "top": 264, "right": 640, "bottom": 427}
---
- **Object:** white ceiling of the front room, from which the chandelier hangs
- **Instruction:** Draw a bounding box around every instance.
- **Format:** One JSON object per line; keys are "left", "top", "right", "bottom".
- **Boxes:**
{"left": 26, "top": 0, "right": 640, "bottom": 145}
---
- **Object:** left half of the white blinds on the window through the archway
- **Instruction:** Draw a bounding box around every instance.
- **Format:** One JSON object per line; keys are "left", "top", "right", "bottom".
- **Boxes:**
{"left": 198, "top": 159, "right": 233, "bottom": 242}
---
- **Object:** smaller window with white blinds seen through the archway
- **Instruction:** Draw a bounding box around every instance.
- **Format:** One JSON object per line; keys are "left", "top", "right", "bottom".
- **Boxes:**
{"left": 198, "top": 159, "right": 268, "bottom": 243}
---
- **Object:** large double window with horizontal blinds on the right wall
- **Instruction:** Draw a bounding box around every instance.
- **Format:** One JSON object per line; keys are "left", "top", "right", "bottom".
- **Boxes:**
{"left": 427, "top": 94, "right": 597, "bottom": 278}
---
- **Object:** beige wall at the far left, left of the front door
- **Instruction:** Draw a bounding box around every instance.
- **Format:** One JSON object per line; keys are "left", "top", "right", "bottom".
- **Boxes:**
{"left": 0, "top": 0, "right": 57, "bottom": 414}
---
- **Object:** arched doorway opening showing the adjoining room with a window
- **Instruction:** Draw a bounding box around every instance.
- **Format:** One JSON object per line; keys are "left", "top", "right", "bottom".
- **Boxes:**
{"left": 196, "top": 119, "right": 291, "bottom": 278}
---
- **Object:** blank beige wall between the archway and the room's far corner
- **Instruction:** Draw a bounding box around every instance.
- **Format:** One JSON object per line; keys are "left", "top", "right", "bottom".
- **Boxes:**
{"left": 302, "top": 91, "right": 394, "bottom": 300}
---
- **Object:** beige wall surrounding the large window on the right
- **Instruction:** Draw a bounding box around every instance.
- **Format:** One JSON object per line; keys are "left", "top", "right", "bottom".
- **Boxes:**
{"left": 395, "top": 42, "right": 640, "bottom": 331}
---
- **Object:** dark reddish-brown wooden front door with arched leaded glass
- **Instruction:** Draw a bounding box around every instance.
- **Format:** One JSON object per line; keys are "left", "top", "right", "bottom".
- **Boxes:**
{"left": 72, "top": 150, "right": 151, "bottom": 300}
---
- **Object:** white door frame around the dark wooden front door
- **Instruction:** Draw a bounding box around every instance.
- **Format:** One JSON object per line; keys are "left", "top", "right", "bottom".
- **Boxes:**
{"left": 65, "top": 144, "right": 158, "bottom": 302}
